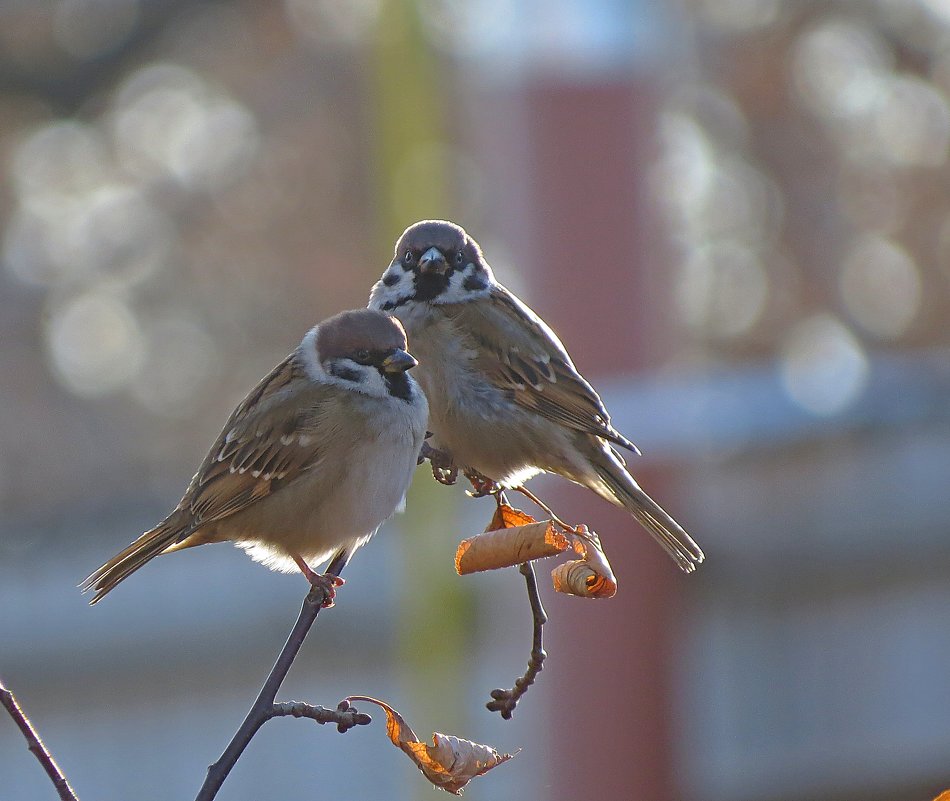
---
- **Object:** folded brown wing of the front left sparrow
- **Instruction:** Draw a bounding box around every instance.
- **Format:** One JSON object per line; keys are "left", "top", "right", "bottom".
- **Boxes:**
{"left": 180, "top": 353, "right": 340, "bottom": 531}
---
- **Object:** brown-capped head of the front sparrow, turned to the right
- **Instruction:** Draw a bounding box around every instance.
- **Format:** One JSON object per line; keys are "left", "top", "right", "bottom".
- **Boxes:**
{"left": 301, "top": 309, "right": 418, "bottom": 401}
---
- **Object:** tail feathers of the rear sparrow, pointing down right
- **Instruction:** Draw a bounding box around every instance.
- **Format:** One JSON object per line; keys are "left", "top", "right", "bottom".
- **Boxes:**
{"left": 592, "top": 457, "right": 706, "bottom": 573}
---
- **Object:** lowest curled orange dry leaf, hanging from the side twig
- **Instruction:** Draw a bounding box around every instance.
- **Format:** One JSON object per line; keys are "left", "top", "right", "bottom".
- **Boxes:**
{"left": 346, "top": 695, "right": 514, "bottom": 795}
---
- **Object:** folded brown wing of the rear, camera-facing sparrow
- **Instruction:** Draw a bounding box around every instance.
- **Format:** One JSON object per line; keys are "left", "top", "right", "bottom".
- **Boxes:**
{"left": 447, "top": 286, "right": 639, "bottom": 453}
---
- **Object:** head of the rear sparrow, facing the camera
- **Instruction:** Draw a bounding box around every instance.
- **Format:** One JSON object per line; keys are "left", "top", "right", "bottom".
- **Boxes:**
{"left": 369, "top": 220, "right": 495, "bottom": 311}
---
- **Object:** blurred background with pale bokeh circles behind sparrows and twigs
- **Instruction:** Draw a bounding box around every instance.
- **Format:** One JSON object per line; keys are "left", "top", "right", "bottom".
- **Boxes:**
{"left": 0, "top": 0, "right": 950, "bottom": 801}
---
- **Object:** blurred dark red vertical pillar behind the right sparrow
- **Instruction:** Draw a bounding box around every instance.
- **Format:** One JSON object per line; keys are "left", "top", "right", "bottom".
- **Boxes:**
{"left": 477, "top": 6, "right": 688, "bottom": 801}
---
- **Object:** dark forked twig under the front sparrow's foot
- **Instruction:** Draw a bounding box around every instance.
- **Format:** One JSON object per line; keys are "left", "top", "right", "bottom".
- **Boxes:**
{"left": 195, "top": 554, "right": 356, "bottom": 801}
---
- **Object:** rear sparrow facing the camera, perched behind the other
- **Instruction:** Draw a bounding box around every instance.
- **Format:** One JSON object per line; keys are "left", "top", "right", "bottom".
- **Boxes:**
{"left": 368, "top": 220, "right": 705, "bottom": 573}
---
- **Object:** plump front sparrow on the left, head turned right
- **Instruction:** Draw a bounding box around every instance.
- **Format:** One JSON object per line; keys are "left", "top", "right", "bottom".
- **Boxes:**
{"left": 80, "top": 309, "right": 428, "bottom": 606}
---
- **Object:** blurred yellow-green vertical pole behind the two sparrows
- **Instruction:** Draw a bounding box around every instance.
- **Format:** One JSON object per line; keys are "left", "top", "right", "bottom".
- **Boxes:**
{"left": 371, "top": 0, "right": 473, "bottom": 764}
